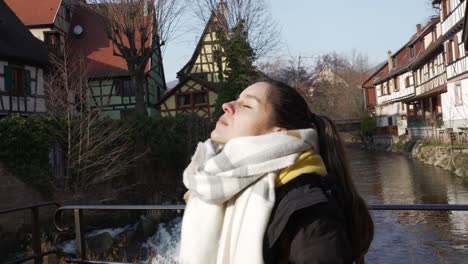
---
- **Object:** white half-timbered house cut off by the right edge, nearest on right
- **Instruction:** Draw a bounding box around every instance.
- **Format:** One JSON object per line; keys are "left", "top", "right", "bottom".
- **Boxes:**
{"left": 433, "top": 0, "right": 468, "bottom": 130}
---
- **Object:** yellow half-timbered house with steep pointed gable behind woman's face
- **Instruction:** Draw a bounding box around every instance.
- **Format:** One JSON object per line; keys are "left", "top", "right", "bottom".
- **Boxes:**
{"left": 157, "top": 3, "right": 226, "bottom": 118}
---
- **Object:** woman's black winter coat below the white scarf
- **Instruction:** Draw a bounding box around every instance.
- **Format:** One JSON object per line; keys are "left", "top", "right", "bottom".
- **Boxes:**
{"left": 263, "top": 174, "right": 353, "bottom": 264}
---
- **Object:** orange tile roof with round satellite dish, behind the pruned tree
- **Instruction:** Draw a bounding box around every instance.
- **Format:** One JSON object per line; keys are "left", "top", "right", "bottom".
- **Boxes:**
{"left": 69, "top": 7, "right": 149, "bottom": 78}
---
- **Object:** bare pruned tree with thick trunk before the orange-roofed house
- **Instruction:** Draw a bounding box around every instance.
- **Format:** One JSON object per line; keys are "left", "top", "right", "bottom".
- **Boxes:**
{"left": 84, "top": 0, "right": 187, "bottom": 116}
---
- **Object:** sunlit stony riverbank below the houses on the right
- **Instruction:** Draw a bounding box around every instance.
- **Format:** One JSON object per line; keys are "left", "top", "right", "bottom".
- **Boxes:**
{"left": 371, "top": 137, "right": 468, "bottom": 179}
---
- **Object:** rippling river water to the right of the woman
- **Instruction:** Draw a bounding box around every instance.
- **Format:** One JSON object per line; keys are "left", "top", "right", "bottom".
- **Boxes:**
{"left": 347, "top": 147, "right": 468, "bottom": 263}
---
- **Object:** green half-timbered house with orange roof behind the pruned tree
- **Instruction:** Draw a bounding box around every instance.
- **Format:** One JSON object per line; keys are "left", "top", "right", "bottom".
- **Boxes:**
{"left": 69, "top": 4, "right": 166, "bottom": 119}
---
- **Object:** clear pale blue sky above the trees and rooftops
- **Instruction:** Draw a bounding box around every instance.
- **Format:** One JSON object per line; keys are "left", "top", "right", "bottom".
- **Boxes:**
{"left": 163, "top": 0, "right": 436, "bottom": 82}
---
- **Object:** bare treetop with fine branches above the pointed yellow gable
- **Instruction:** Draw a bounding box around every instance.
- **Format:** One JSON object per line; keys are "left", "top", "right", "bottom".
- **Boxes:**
{"left": 194, "top": 0, "right": 280, "bottom": 58}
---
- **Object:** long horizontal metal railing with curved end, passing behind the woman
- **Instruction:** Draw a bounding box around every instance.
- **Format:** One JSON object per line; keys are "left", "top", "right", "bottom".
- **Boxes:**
{"left": 54, "top": 204, "right": 468, "bottom": 264}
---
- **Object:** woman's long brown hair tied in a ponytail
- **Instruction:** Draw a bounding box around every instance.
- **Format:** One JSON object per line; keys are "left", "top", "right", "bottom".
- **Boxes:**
{"left": 260, "top": 80, "right": 374, "bottom": 263}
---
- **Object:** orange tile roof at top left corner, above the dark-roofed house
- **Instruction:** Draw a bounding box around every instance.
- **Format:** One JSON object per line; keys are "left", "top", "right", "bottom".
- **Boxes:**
{"left": 5, "top": 0, "right": 62, "bottom": 26}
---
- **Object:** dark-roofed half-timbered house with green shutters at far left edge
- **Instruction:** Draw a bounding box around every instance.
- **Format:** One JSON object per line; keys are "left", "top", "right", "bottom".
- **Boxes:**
{"left": 0, "top": 1, "right": 48, "bottom": 115}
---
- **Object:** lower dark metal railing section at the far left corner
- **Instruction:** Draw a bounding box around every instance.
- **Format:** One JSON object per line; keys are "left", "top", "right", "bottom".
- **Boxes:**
{"left": 0, "top": 202, "right": 60, "bottom": 264}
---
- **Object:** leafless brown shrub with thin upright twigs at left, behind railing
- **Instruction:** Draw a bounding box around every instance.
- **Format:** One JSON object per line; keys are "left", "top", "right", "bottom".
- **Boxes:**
{"left": 44, "top": 46, "right": 136, "bottom": 191}
